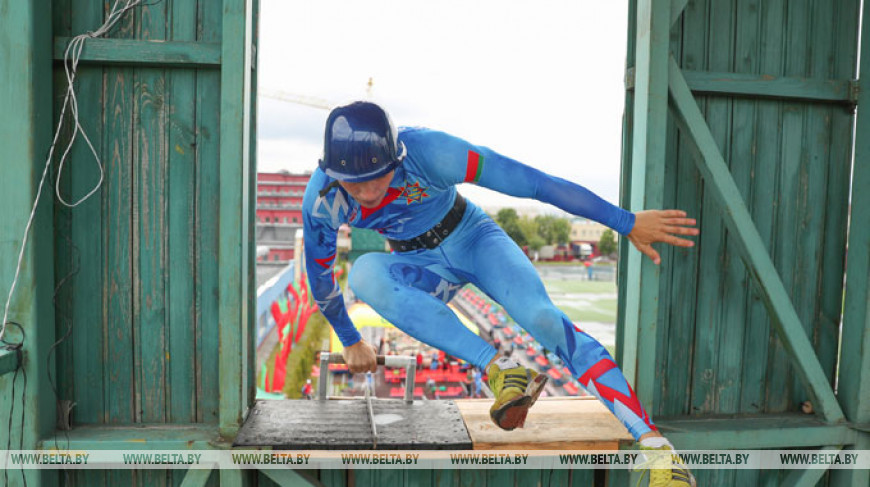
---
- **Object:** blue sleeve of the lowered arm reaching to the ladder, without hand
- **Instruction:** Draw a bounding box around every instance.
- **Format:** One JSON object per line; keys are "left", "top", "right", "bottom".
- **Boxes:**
{"left": 302, "top": 173, "right": 362, "bottom": 347}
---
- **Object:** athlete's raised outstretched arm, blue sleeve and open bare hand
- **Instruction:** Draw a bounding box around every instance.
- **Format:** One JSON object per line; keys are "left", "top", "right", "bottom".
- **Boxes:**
{"left": 406, "top": 129, "right": 698, "bottom": 264}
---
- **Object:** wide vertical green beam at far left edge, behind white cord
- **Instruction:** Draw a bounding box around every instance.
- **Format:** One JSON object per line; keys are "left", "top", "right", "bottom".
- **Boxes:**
{"left": 0, "top": 0, "right": 58, "bottom": 485}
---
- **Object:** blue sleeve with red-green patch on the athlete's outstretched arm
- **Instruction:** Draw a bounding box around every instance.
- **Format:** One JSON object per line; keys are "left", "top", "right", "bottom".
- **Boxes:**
{"left": 406, "top": 129, "right": 634, "bottom": 235}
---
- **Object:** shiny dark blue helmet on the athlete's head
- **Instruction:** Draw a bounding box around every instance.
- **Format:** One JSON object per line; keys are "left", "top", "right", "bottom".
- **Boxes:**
{"left": 320, "top": 101, "right": 405, "bottom": 183}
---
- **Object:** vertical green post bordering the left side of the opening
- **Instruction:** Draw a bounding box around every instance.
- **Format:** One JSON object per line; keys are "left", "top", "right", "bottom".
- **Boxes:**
{"left": 218, "top": 0, "right": 251, "bottom": 436}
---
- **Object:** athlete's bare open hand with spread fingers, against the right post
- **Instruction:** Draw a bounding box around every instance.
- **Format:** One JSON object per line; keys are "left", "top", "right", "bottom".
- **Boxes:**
{"left": 628, "top": 210, "right": 701, "bottom": 265}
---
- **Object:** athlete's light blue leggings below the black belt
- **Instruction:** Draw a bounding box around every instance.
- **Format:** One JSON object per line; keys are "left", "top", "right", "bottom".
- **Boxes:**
{"left": 348, "top": 202, "right": 655, "bottom": 439}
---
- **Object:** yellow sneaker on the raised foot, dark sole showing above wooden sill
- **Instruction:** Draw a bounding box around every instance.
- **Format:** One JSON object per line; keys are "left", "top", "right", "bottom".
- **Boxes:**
{"left": 486, "top": 358, "right": 548, "bottom": 431}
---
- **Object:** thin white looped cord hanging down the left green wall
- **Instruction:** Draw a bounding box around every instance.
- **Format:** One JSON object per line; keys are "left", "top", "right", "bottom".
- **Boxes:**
{"left": 0, "top": 0, "right": 142, "bottom": 340}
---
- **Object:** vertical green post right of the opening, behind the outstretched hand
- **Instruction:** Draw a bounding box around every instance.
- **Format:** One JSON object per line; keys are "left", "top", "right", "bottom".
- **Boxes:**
{"left": 619, "top": 0, "right": 670, "bottom": 409}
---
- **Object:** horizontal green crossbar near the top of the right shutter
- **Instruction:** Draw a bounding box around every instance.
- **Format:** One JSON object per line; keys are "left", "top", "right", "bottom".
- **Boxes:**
{"left": 684, "top": 71, "right": 855, "bottom": 105}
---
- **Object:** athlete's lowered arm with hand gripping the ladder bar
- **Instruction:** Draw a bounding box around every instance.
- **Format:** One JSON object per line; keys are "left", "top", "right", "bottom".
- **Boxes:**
{"left": 302, "top": 176, "right": 378, "bottom": 373}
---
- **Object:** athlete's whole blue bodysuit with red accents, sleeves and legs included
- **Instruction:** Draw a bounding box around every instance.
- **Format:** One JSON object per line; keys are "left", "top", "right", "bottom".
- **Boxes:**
{"left": 303, "top": 128, "right": 655, "bottom": 438}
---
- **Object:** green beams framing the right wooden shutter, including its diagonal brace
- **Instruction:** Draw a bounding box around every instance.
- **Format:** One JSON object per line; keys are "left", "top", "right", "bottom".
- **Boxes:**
{"left": 620, "top": 0, "right": 870, "bottom": 486}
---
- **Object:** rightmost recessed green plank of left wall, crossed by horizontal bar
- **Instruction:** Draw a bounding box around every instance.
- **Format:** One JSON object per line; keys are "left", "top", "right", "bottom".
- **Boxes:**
{"left": 194, "top": 2, "right": 223, "bottom": 424}
